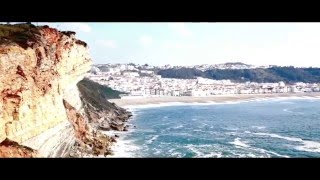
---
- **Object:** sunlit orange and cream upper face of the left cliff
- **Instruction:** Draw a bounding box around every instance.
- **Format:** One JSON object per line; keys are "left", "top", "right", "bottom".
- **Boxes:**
{"left": 0, "top": 25, "right": 91, "bottom": 158}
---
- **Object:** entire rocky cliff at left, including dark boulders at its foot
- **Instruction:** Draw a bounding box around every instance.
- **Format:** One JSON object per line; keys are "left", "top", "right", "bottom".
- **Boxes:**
{"left": 0, "top": 24, "right": 131, "bottom": 157}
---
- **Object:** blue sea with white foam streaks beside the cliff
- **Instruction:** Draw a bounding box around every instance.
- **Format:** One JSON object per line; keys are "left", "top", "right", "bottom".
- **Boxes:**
{"left": 117, "top": 98, "right": 320, "bottom": 158}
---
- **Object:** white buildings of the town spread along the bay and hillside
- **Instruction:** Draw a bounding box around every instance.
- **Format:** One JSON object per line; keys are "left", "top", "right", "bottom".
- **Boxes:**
{"left": 87, "top": 63, "right": 320, "bottom": 98}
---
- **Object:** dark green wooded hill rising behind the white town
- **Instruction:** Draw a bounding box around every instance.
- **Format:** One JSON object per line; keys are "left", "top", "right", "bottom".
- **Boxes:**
{"left": 156, "top": 66, "right": 320, "bottom": 83}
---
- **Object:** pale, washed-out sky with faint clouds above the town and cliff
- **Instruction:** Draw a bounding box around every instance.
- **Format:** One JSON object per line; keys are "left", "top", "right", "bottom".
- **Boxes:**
{"left": 8, "top": 23, "right": 320, "bottom": 67}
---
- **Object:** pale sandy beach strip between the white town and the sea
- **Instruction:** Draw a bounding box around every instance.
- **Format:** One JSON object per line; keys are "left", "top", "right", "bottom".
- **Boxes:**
{"left": 109, "top": 92, "right": 320, "bottom": 107}
